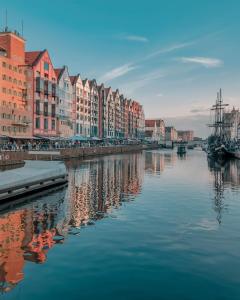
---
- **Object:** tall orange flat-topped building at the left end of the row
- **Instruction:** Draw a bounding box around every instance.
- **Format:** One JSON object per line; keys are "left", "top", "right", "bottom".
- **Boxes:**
{"left": 0, "top": 31, "right": 32, "bottom": 138}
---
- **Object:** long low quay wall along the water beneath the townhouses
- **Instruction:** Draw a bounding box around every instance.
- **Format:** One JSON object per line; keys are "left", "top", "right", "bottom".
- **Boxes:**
{"left": 0, "top": 144, "right": 160, "bottom": 166}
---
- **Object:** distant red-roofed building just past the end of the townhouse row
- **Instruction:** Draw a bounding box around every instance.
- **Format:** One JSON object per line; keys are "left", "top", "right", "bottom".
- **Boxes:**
{"left": 145, "top": 119, "right": 165, "bottom": 142}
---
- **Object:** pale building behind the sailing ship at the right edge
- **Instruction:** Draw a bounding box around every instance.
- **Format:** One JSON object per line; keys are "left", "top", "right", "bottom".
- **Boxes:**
{"left": 223, "top": 108, "right": 240, "bottom": 139}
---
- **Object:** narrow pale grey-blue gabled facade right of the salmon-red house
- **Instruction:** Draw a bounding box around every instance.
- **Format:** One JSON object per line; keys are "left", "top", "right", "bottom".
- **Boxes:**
{"left": 55, "top": 66, "right": 76, "bottom": 137}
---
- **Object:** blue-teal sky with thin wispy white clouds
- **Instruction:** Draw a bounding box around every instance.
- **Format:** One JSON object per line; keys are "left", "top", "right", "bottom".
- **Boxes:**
{"left": 0, "top": 0, "right": 240, "bottom": 136}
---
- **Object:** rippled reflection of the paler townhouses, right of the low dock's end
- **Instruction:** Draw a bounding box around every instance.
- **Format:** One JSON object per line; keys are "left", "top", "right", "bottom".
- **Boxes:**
{"left": 68, "top": 153, "right": 144, "bottom": 227}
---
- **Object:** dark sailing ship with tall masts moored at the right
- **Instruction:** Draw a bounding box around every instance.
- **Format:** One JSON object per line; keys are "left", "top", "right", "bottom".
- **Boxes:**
{"left": 207, "top": 89, "right": 240, "bottom": 159}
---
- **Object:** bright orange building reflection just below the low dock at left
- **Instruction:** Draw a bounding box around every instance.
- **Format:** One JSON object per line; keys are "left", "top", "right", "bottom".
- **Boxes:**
{"left": 0, "top": 189, "right": 66, "bottom": 292}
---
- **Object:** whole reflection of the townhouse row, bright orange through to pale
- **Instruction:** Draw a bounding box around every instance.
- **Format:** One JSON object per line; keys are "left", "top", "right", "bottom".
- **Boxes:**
{"left": 0, "top": 153, "right": 144, "bottom": 292}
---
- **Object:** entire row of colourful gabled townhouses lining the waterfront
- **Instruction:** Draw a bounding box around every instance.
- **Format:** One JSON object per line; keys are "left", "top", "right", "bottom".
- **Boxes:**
{"left": 0, "top": 29, "right": 145, "bottom": 139}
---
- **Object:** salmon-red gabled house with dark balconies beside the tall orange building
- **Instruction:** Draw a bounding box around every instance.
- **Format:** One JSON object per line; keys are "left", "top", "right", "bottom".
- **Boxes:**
{"left": 25, "top": 50, "right": 58, "bottom": 137}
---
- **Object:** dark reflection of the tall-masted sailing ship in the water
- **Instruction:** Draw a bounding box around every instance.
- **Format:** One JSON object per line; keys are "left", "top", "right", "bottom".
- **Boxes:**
{"left": 208, "top": 160, "right": 240, "bottom": 224}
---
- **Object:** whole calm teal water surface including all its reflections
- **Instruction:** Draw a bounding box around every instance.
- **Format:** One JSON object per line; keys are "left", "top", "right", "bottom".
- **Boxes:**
{"left": 0, "top": 150, "right": 240, "bottom": 300}
